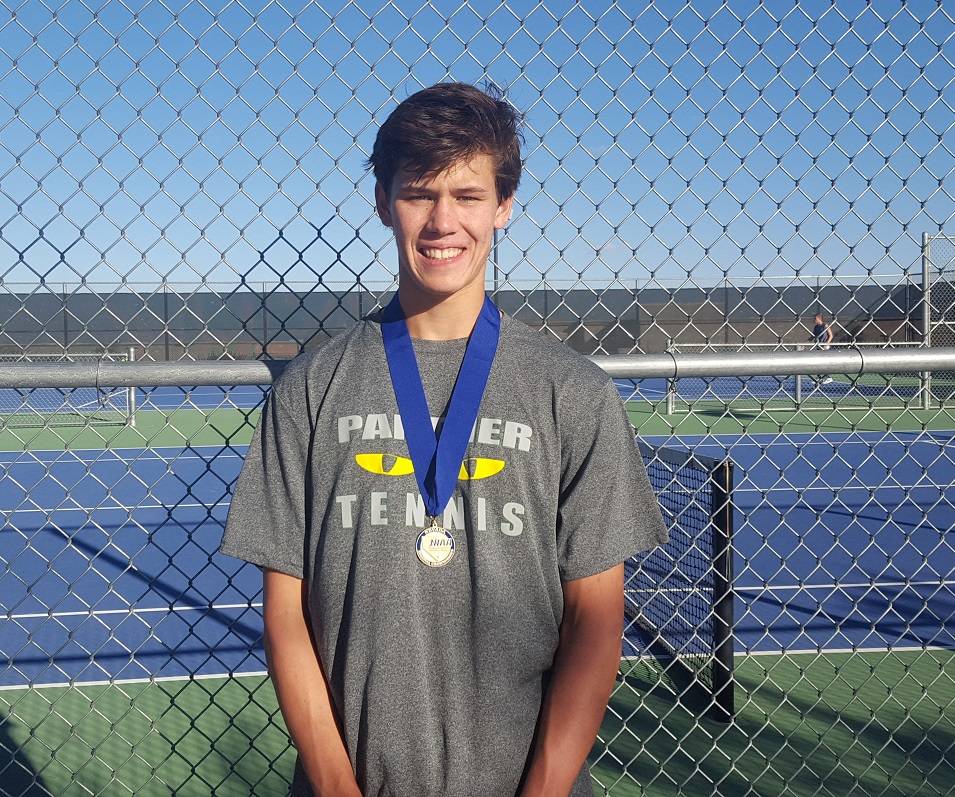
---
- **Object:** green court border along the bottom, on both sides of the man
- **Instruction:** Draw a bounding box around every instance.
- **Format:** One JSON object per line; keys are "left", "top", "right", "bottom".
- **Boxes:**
{"left": 0, "top": 650, "right": 955, "bottom": 797}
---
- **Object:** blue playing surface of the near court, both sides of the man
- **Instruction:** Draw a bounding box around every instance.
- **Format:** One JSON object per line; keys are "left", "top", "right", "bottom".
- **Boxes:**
{"left": 0, "top": 426, "right": 955, "bottom": 686}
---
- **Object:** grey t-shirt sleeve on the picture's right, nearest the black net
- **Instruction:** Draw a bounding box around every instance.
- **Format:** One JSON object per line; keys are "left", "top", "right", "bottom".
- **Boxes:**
{"left": 557, "top": 382, "right": 667, "bottom": 581}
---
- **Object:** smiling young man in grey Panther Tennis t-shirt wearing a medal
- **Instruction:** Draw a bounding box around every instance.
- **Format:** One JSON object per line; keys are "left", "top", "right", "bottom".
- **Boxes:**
{"left": 222, "top": 84, "right": 666, "bottom": 797}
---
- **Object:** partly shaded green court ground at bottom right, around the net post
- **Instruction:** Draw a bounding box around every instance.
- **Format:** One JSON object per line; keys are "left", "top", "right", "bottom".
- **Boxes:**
{"left": 590, "top": 651, "right": 955, "bottom": 797}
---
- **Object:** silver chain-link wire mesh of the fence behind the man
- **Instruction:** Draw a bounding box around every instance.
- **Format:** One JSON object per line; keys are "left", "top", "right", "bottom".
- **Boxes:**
{"left": 0, "top": 0, "right": 955, "bottom": 797}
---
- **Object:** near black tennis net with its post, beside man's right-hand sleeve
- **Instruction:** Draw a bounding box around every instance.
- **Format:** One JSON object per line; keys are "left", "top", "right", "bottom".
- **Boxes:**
{"left": 624, "top": 442, "right": 734, "bottom": 721}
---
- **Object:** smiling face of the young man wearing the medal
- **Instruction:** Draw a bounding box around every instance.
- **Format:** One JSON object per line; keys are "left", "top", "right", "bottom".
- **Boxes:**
{"left": 375, "top": 155, "right": 513, "bottom": 309}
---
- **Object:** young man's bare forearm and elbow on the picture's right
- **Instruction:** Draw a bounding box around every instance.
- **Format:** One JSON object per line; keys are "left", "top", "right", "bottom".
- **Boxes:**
{"left": 520, "top": 564, "right": 623, "bottom": 797}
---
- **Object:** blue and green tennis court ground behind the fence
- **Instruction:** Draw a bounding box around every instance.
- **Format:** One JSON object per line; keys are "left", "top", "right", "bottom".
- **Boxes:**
{"left": 0, "top": 386, "right": 955, "bottom": 795}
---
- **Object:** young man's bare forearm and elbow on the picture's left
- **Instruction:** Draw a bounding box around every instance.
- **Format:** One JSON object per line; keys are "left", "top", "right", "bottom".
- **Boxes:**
{"left": 263, "top": 569, "right": 361, "bottom": 797}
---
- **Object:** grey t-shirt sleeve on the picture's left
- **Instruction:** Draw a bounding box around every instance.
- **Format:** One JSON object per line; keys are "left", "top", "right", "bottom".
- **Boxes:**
{"left": 219, "top": 388, "right": 309, "bottom": 578}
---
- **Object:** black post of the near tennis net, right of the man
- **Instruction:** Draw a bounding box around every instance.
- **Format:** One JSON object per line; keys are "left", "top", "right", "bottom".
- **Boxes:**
{"left": 709, "top": 459, "right": 736, "bottom": 722}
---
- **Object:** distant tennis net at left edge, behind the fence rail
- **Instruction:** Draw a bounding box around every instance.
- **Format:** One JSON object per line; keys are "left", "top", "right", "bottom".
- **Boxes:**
{"left": 0, "top": 350, "right": 136, "bottom": 426}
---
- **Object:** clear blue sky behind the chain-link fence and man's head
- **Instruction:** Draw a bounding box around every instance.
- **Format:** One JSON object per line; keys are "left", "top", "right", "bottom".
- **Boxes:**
{"left": 0, "top": 0, "right": 955, "bottom": 286}
